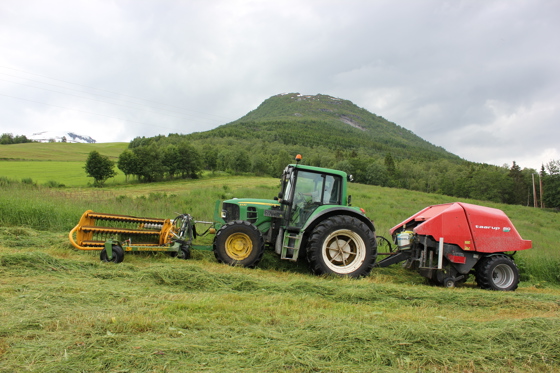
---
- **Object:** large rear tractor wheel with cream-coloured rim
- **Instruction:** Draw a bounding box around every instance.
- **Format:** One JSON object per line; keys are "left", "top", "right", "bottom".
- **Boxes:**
{"left": 307, "top": 215, "right": 377, "bottom": 277}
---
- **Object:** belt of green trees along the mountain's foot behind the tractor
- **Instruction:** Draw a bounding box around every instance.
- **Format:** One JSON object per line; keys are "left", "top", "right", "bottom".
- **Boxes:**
{"left": 83, "top": 134, "right": 560, "bottom": 208}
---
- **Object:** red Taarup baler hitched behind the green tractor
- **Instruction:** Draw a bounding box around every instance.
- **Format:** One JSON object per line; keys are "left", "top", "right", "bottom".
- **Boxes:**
{"left": 377, "top": 202, "right": 531, "bottom": 290}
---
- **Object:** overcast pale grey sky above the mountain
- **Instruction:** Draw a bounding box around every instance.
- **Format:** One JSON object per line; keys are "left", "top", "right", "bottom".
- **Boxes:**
{"left": 0, "top": 0, "right": 560, "bottom": 168}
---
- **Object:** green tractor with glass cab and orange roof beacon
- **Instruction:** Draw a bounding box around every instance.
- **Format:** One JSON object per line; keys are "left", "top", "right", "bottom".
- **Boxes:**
{"left": 213, "top": 155, "right": 377, "bottom": 277}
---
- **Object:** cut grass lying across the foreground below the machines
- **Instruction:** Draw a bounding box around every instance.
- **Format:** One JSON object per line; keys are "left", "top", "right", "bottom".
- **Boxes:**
{"left": 0, "top": 227, "right": 560, "bottom": 372}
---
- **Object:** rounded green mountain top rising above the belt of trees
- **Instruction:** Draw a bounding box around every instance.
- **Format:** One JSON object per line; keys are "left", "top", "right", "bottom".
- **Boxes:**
{"left": 191, "top": 93, "right": 460, "bottom": 161}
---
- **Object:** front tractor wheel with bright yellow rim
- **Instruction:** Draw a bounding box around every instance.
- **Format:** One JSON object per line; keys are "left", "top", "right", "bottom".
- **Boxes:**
{"left": 214, "top": 220, "right": 264, "bottom": 268}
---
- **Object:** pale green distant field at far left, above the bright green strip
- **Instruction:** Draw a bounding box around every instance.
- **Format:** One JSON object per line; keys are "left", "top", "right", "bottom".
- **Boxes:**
{"left": 0, "top": 142, "right": 128, "bottom": 162}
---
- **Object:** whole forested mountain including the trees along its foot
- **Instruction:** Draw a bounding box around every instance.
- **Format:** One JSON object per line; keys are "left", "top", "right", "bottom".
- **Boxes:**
{"left": 110, "top": 93, "right": 560, "bottom": 207}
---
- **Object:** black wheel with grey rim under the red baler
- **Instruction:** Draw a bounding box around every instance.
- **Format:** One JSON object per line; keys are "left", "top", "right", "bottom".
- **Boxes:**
{"left": 475, "top": 255, "right": 519, "bottom": 291}
